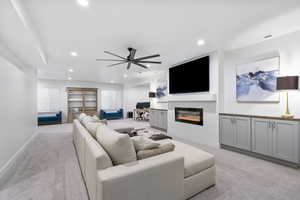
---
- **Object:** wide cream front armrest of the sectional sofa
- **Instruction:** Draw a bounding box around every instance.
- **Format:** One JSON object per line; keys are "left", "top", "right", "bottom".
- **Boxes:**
{"left": 97, "top": 153, "right": 184, "bottom": 200}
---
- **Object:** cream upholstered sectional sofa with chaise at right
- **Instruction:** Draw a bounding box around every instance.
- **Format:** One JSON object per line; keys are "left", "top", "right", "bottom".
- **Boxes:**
{"left": 73, "top": 119, "right": 215, "bottom": 200}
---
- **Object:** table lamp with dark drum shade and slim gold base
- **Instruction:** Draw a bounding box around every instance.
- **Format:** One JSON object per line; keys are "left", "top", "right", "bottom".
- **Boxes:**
{"left": 276, "top": 76, "right": 299, "bottom": 119}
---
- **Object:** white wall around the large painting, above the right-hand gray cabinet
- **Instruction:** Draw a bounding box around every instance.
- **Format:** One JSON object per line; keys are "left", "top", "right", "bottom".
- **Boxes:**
{"left": 220, "top": 32, "right": 300, "bottom": 117}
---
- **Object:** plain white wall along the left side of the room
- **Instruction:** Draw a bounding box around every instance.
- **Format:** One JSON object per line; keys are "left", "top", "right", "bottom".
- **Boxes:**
{"left": 0, "top": 57, "right": 37, "bottom": 173}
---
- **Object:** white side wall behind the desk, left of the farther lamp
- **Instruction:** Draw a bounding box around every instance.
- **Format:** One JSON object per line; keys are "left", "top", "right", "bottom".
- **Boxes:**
{"left": 123, "top": 84, "right": 150, "bottom": 115}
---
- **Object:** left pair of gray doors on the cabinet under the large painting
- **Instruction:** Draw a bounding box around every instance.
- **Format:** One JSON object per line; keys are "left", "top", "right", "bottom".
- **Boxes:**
{"left": 220, "top": 116, "right": 251, "bottom": 151}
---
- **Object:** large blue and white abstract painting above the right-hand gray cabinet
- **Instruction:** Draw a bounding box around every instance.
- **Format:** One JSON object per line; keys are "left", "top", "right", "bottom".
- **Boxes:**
{"left": 236, "top": 57, "right": 279, "bottom": 102}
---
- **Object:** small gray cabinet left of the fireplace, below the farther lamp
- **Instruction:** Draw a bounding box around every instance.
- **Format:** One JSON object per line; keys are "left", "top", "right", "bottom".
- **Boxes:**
{"left": 149, "top": 109, "right": 168, "bottom": 130}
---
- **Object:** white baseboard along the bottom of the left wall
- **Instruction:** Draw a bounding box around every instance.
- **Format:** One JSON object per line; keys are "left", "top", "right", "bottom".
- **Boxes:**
{"left": 0, "top": 131, "right": 38, "bottom": 188}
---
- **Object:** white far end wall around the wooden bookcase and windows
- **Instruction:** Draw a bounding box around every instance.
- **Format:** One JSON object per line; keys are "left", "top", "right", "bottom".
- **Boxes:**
{"left": 38, "top": 80, "right": 123, "bottom": 122}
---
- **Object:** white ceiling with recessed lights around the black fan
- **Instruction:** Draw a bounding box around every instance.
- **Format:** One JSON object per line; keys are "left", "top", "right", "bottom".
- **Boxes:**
{"left": 0, "top": 0, "right": 300, "bottom": 83}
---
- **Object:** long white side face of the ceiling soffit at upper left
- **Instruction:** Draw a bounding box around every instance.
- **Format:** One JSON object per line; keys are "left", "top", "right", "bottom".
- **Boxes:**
{"left": 10, "top": 0, "right": 48, "bottom": 64}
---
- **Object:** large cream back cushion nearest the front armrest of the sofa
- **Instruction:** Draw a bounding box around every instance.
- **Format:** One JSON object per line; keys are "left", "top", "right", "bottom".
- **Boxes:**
{"left": 97, "top": 125, "right": 137, "bottom": 165}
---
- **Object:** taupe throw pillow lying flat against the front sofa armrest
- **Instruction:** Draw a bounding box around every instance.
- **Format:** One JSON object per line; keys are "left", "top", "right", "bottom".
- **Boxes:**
{"left": 137, "top": 143, "right": 175, "bottom": 160}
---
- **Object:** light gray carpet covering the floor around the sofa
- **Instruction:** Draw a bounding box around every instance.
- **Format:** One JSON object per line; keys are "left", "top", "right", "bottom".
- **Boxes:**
{"left": 0, "top": 121, "right": 300, "bottom": 200}
